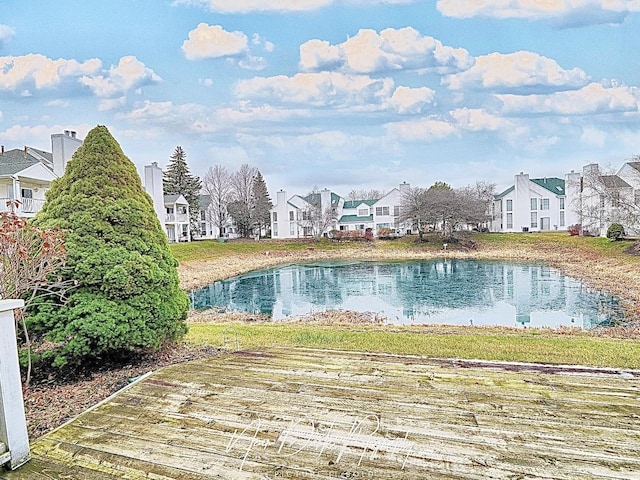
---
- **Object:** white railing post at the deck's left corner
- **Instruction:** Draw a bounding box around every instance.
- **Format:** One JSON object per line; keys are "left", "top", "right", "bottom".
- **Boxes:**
{"left": 0, "top": 300, "right": 30, "bottom": 470}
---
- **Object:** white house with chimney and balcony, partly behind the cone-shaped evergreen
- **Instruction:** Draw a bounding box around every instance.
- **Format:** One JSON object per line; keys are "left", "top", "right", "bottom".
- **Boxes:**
{"left": 0, "top": 130, "right": 82, "bottom": 218}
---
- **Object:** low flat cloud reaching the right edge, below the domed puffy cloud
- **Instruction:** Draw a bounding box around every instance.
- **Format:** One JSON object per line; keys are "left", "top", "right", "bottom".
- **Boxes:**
{"left": 496, "top": 83, "right": 640, "bottom": 115}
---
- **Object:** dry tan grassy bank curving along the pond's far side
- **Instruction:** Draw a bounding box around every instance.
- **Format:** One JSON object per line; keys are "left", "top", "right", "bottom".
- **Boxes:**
{"left": 179, "top": 237, "right": 640, "bottom": 330}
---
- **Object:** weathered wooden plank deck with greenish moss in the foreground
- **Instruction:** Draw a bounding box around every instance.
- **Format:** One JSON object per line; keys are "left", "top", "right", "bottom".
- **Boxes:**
{"left": 0, "top": 350, "right": 640, "bottom": 480}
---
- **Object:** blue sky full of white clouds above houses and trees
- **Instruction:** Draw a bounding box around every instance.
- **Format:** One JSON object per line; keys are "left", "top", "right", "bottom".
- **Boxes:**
{"left": 0, "top": 0, "right": 640, "bottom": 200}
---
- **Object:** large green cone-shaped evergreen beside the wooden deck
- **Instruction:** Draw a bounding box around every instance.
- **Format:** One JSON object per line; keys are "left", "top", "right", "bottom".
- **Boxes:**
{"left": 29, "top": 126, "right": 189, "bottom": 366}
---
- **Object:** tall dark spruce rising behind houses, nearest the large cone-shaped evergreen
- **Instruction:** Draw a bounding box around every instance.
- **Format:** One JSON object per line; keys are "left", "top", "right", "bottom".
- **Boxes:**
{"left": 162, "top": 145, "right": 202, "bottom": 232}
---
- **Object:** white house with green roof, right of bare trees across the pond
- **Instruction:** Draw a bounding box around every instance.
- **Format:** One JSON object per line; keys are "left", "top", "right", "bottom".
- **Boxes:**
{"left": 489, "top": 172, "right": 577, "bottom": 232}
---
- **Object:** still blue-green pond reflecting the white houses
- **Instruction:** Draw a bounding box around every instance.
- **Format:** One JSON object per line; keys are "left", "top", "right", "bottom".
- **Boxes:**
{"left": 191, "top": 259, "right": 621, "bottom": 328}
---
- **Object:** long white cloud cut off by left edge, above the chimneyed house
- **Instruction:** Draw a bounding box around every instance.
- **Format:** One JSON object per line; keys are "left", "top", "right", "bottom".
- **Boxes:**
{"left": 0, "top": 53, "right": 102, "bottom": 92}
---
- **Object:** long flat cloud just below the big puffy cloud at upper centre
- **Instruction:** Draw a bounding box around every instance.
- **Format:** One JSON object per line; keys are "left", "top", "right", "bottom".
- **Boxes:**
{"left": 234, "top": 72, "right": 393, "bottom": 107}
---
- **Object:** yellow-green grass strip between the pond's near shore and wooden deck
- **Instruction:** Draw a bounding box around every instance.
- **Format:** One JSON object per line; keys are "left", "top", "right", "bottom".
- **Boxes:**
{"left": 186, "top": 322, "right": 640, "bottom": 369}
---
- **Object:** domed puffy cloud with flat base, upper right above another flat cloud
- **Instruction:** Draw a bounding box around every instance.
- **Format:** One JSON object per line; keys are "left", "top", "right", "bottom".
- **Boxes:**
{"left": 443, "top": 51, "right": 588, "bottom": 90}
